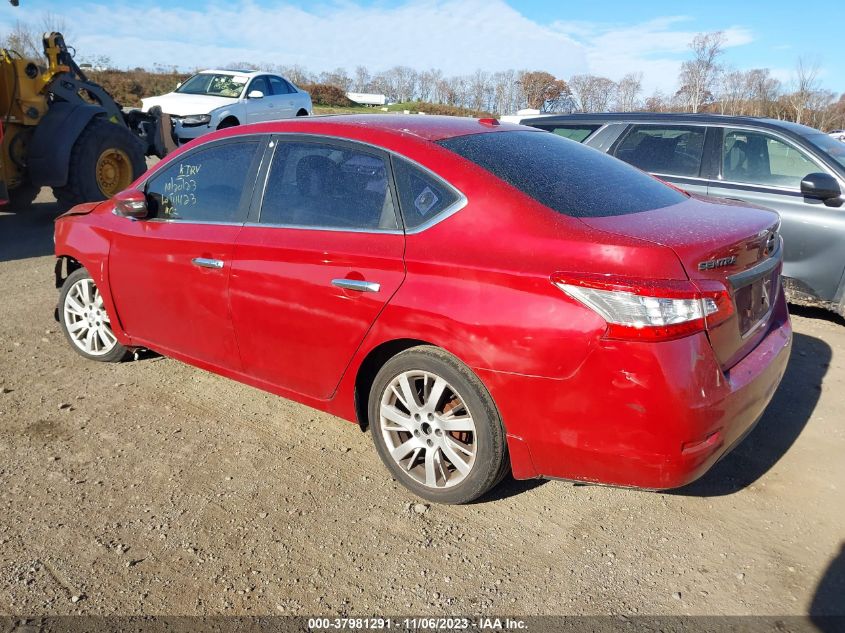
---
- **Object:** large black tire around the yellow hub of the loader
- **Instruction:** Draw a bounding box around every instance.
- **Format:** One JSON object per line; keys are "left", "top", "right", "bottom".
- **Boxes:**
{"left": 53, "top": 117, "right": 147, "bottom": 208}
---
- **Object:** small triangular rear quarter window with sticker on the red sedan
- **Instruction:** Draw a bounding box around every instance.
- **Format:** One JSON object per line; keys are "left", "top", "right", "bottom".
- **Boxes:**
{"left": 393, "top": 158, "right": 460, "bottom": 230}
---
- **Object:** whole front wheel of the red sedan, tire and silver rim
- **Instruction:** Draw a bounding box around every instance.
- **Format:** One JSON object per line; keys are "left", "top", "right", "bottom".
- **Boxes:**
{"left": 59, "top": 268, "right": 129, "bottom": 363}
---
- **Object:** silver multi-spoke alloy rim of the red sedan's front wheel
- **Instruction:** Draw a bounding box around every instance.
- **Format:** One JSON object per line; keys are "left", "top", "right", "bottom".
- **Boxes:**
{"left": 62, "top": 278, "right": 117, "bottom": 356}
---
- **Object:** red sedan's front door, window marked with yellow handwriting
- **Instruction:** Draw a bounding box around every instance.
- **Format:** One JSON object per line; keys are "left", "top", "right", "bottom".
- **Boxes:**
{"left": 109, "top": 137, "right": 261, "bottom": 368}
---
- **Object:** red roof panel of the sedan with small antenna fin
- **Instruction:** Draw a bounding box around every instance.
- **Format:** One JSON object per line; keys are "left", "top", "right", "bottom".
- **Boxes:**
{"left": 224, "top": 114, "right": 541, "bottom": 141}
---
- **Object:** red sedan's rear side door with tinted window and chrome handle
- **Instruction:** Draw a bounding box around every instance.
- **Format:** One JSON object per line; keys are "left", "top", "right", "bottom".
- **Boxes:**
{"left": 230, "top": 136, "right": 405, "bottom": 399}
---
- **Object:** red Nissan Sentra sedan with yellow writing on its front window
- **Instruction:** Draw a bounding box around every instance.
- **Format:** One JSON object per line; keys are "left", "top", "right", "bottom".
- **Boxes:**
{"left": 56, "top": 115, "right": 792, "bottom": 503}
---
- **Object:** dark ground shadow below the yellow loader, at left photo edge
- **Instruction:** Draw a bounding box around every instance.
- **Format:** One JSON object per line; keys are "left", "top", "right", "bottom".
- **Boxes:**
{"left": 0, "top": 195, "right": 61, "bottom": 262}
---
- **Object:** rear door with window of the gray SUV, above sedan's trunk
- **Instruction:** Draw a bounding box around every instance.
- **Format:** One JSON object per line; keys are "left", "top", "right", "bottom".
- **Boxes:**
{"left": 611, "top": 123, "right": 707, "bottom": 194}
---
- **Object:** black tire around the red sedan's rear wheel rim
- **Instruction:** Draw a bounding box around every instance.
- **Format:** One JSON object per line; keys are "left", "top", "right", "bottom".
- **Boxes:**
{"left": 368, "top": 345, "right": 510, "bottom": 504}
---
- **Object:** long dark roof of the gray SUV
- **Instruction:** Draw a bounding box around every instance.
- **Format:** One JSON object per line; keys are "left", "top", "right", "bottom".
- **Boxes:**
{"left": 522, "top": 112, "right": 822, "bottom": 136}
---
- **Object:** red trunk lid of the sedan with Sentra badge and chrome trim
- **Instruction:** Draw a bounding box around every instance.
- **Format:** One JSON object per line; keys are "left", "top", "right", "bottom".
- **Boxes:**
{"left": 581, "top": 197, "right": 782, "bottom": 369}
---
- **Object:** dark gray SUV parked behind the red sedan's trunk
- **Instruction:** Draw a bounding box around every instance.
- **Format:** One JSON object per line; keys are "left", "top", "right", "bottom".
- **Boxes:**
{"left": 521, "top": 112, "right": 845, "bottom": 316}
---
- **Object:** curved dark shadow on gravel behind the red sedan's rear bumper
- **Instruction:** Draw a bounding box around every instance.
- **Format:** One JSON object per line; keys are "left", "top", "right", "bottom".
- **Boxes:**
{"left": 669, "top": 334, "right": 833, "bottom": 497}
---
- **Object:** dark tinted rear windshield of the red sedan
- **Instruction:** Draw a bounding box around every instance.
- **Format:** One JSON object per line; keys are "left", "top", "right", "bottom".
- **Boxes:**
{"left": 439, "top": 132, "right": 686, "bottom": 218}
